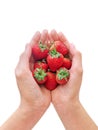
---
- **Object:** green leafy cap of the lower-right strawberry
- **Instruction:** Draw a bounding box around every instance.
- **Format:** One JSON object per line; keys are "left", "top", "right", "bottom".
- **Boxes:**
{"left": 57, "top": 68, "right": 70, "bottom": 80}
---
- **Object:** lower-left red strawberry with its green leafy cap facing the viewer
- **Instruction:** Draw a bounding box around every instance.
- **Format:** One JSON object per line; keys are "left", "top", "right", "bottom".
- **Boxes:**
{"left": 32, "top": 68, "right": 47, "bottom": 84}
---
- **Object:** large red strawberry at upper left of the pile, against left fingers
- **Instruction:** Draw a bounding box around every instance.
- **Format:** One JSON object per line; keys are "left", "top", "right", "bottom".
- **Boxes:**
{"left": 32, "top": 42, "right": 49, "bottom": 60}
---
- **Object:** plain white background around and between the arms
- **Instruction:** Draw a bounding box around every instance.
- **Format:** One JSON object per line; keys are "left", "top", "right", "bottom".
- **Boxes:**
{"left": 0, "top": 0, "right": 98, "bottom": 130}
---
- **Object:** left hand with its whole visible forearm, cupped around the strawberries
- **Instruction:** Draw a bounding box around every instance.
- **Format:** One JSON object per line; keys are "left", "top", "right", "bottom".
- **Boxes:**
{"left": 0, "top": 30, "right": 51, "bottom": 130}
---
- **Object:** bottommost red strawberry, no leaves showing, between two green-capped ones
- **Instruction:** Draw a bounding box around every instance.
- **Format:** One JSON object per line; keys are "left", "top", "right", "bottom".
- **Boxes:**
{"left": 45, "top": 72, "right": 57, "bottom": 90}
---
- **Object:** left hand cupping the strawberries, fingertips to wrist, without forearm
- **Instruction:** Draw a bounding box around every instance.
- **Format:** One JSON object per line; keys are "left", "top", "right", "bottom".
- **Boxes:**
{"left": 15, "top": 30, "right": 51, "bottom": 122}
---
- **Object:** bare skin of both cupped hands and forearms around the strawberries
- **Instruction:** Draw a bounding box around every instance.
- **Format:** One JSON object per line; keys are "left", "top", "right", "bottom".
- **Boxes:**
{"left": 0, "top": 30, "right": 98, "bottom": 130}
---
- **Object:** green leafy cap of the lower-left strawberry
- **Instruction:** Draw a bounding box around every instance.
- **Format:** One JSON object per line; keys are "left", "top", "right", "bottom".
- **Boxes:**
{"left": 34, "top": 68, "right": 47, "bottom": 81}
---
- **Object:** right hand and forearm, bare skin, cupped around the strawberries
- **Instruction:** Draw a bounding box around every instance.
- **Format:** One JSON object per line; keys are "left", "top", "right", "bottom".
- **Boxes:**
{"left": 50, "top": 30, "right": 98, "bottom": 130}
